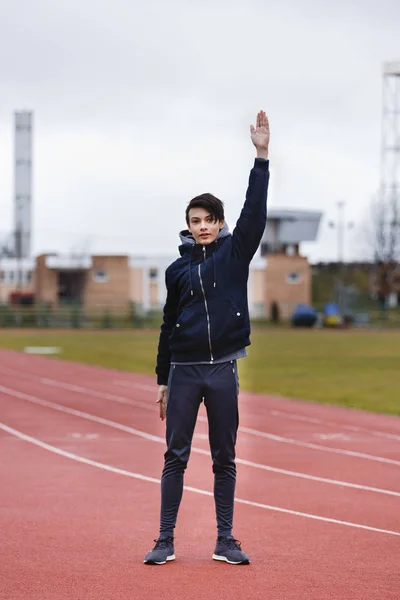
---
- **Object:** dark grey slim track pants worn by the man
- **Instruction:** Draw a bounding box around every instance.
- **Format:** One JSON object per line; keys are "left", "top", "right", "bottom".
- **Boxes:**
{"left": 160, "top": 361, "right": 239, "bottom": 536}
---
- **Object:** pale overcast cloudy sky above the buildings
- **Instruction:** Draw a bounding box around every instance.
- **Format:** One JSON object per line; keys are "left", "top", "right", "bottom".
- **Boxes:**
{"left": 0, "top": 0, "right": 400, "bottom": 260}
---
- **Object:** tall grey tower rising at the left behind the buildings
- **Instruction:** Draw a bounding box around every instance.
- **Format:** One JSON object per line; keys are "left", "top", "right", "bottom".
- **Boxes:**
{"left": 14, "top": 111, "right": 32, "bottom": 259}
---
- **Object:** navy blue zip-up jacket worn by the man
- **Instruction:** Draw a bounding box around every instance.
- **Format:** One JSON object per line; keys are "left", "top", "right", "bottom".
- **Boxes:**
{"left": 156, "top": 158, "right": 269, "bottom": 385}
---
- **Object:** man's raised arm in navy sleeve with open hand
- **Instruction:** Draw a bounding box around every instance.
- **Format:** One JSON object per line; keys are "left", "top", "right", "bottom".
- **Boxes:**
{"left": 232, "top": 111, "right": 270, "bottom": 262}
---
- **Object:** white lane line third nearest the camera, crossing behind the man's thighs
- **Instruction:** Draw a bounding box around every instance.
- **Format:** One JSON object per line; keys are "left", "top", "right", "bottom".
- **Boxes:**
{"left": 0, "top": 368, "right": 400, "bottom": 466}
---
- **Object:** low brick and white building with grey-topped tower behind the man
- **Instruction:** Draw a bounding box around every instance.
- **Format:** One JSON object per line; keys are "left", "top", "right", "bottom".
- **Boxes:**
{"left": 0, "top": 210, "right": 321, "bottom": 318}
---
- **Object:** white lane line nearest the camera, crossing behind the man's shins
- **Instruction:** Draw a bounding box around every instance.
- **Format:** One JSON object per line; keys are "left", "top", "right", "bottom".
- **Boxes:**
{"left": 0, "top": 423, "right": 400, "bottom": 536}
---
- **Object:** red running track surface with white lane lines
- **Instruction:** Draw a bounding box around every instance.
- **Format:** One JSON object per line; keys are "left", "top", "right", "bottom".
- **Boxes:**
{"left": 0, "top": 351, "right": 400, "bottom": 600}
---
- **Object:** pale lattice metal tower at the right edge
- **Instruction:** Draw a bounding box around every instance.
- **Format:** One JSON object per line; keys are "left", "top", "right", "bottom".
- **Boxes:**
{"left": 376, "top": 62, "right": 400, "bottom": 262}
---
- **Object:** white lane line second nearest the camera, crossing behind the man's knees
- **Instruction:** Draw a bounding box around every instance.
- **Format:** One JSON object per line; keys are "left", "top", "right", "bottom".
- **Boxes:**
{"left": 0, "top": 385, "right": 400, "bottom": 497}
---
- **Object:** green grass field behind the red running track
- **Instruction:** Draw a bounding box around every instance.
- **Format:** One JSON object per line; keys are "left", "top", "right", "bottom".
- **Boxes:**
{"left": 0, "top": 329, "right": 400, "bottom": 415}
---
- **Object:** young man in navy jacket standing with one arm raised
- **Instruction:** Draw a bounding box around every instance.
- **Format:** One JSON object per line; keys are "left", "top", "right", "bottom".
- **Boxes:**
{"left": 144, "top": 111, "right": 269, "bottom": 565}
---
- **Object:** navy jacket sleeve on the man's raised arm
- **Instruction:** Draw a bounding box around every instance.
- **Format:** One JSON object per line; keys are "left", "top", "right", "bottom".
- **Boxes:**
{"left": 232, "top": 158, "right": 269, "bottom": 263}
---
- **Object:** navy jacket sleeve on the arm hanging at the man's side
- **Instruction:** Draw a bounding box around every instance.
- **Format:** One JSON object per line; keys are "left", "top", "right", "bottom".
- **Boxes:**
{"left": 156, "top": 269, "right": 178, "bottom": 385}
